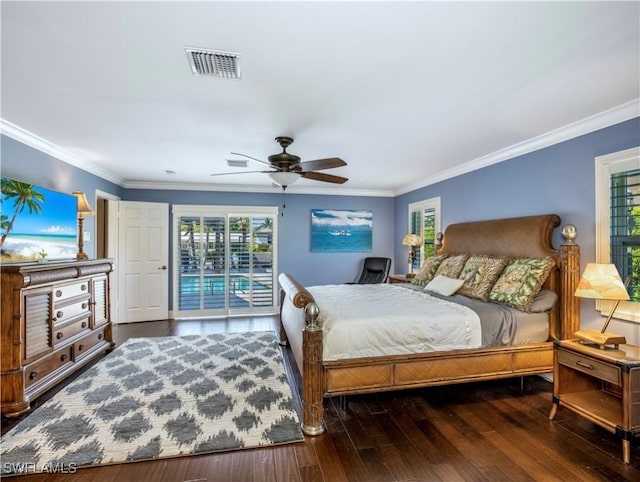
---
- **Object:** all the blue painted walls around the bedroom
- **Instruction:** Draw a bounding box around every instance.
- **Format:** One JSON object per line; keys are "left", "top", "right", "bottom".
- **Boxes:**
{"left": 5, "top": 117, "right": 640, "bottom": 334}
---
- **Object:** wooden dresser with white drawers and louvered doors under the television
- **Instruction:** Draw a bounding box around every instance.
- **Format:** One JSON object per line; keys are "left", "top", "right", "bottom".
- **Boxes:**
{"left": 0, "top": 259, "right": 114, "bottom": 417}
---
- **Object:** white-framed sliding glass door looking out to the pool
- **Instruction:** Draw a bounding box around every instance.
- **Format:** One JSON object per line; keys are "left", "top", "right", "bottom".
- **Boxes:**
{"left": 173, "top": 206, "right": 278, "bottom": 317}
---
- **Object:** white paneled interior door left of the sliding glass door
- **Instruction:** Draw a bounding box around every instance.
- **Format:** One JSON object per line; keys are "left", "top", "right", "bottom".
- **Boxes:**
{"left": 117, "top": 201, "right": 169, "bottom": 323}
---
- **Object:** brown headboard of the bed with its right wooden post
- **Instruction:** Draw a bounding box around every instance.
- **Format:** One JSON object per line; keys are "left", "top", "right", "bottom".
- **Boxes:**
{"left": 437, "top": 214, "right": 580, "bottom": 339}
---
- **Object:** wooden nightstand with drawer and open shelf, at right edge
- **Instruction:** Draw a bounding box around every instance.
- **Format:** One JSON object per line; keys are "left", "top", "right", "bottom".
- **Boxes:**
{"left": 549, "top": 340, "right": 640, "bottom": 464}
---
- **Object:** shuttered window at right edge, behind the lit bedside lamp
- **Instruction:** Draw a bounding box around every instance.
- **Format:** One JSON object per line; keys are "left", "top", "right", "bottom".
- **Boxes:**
{"left": 609, "top": 169, "right": 640, "bottom": 301}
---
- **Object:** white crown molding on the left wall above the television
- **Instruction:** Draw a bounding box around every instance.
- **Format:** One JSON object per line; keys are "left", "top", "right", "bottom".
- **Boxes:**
{"left": 0, "top": 118, "right": 124, "bottom": 186}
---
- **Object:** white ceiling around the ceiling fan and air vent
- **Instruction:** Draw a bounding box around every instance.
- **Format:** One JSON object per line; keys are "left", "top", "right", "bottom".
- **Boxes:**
{"left": 1, "top": 0, "right": 640, "bottom": 195}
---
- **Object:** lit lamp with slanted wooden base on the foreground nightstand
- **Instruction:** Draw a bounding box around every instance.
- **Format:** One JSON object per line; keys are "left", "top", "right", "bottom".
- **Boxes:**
{"left": 574, "top": 263, "right": 631, "bottom": 348}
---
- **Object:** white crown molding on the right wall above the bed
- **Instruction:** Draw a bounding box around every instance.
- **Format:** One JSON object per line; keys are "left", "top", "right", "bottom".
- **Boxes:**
{"left": 394, "top": 99, "right": 640, "bottom": 196}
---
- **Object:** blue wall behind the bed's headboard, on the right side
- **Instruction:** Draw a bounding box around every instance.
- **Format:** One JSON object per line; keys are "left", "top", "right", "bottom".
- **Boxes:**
{"left": 394, "top": 118, "right": 640, "bottom": 338}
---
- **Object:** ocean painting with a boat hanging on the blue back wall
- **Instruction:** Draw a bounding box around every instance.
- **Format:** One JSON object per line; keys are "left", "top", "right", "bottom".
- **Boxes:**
{"left": 311, "top": 209, "right": 373, "bottom": 253}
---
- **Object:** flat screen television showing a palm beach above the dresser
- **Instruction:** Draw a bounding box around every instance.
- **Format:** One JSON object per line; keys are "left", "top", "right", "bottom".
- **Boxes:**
{"left": 0, "top": 177, "right": 78, "bottom": 263}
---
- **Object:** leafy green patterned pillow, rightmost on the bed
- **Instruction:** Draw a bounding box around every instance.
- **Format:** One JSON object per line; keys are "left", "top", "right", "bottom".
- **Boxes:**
{"left": 489, "top": 256, "right": 555, "bottom": 312}
